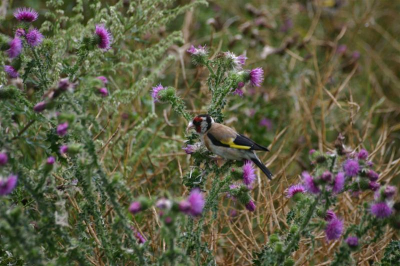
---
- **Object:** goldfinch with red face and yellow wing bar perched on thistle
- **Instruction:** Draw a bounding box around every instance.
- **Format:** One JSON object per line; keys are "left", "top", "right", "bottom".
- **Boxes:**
{"left": 186, "top": 114, "right": 273, "bottom": 179}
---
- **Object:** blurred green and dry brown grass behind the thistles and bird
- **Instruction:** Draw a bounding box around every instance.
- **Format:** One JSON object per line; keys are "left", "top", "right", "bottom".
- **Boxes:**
{"left": 0, "top": 0, "right": 400, "bottom": 265}
